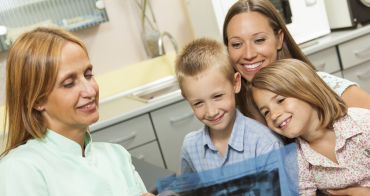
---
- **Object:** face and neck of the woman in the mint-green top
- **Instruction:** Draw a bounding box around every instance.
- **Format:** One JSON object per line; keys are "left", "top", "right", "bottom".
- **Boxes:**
{"left": 40, "top": 42, "right": 99, "bottom": 142}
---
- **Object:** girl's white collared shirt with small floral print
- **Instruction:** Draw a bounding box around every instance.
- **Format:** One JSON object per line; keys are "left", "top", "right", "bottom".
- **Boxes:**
{"left": 297, "top": 108, "right": 370, "bottom": 195}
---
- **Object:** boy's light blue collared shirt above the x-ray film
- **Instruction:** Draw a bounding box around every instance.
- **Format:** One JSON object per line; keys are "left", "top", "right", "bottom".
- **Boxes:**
{"left": 181, "top": 111, "right": 283, "bottom": 173}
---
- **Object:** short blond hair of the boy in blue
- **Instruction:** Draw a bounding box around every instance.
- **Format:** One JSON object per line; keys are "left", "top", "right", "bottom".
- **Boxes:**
{"left": 175, "top": 38, "right": 235, "bottom": 97}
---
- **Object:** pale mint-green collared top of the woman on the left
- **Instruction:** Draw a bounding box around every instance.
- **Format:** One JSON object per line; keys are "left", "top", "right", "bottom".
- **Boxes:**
{"left": 0, "top": 130, "right": 146, "bottom": 196}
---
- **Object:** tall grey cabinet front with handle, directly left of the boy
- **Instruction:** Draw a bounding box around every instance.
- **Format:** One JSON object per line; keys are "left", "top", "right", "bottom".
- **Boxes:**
{"left": 151, "top": 101, "right": 202, "bottom": 173}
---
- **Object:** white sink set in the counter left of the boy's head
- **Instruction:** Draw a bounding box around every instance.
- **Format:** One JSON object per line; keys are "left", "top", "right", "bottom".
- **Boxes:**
{"left": 127, "top": 76, "right": 181, "bottom": 103}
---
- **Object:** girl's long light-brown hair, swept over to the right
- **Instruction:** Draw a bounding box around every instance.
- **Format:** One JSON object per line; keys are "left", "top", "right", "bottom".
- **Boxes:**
{"left": 251, "top": 59, "right": 347, "bottom": 128}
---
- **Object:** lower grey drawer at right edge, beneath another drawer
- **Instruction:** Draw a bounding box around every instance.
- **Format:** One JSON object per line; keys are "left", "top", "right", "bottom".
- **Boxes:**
{"left": 343, "top": 61, "right": 370, "bottom": 93}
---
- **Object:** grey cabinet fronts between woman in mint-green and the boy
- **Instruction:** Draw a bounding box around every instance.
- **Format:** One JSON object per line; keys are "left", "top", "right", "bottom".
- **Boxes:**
{"left": 92, "top": 99, "right": 202, "bottom": 173}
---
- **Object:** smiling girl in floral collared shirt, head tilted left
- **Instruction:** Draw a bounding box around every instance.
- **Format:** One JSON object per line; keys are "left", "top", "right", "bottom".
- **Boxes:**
{"left": 251, "top": 59, "right": 370, "bottom": 195}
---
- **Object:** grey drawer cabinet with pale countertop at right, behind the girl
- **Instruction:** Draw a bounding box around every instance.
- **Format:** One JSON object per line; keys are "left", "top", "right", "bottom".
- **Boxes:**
{"left": 303, "top": 25, "right": 370, "bottom": 93}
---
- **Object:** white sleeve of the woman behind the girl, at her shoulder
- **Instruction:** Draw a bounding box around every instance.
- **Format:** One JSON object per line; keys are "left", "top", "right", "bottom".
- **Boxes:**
{"left": 317, "top": 71, "right": 358, "bottom": 96}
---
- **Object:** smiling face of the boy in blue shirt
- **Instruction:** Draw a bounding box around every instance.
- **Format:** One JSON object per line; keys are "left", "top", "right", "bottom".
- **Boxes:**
{"left": 183, "top": 66, "right": 240, "bottom": 133}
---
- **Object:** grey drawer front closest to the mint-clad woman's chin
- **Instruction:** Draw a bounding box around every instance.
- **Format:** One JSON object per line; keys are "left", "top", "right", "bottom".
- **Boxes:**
{"left": 92, "top": 114, "right": 155, "bottom": 149}
